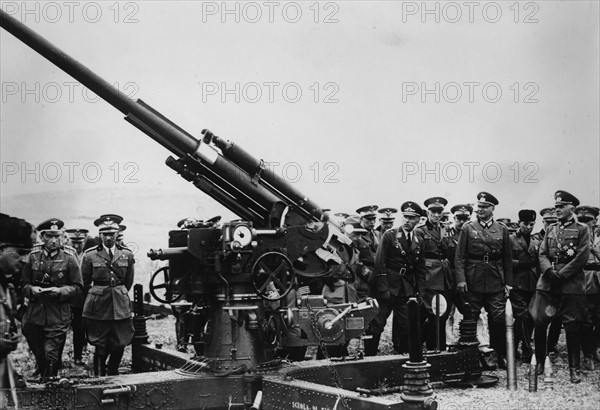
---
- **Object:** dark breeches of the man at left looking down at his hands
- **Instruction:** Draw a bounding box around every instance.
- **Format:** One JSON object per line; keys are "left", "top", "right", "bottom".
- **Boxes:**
{"left": 23, "top": 323, "right": 69, "bottom": 370}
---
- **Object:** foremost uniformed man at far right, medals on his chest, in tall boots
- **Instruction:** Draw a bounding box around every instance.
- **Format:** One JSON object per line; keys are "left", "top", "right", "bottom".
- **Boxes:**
{"left": 530, "top": 191, "right": 590, "bottom": 383}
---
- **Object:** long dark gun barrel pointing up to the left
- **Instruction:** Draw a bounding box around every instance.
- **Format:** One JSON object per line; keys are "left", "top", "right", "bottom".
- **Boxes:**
{"left": 0, "top": 10, "right": 323, "bottom": 227}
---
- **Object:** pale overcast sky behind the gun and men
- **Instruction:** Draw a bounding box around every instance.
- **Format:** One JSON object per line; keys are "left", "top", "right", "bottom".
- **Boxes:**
{"left": 0, "top": 1, "right": 600, "bottom": 229}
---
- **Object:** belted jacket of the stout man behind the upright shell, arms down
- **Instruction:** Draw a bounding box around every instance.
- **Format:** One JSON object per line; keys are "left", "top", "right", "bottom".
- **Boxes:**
{"left": 455, "top": 220, "right": 513, "bottom": 293}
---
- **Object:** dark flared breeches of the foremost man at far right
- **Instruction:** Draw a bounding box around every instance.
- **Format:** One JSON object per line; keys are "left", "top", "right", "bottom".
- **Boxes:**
{"left": 529, "top": 290, "right": 585, "bottom": 332}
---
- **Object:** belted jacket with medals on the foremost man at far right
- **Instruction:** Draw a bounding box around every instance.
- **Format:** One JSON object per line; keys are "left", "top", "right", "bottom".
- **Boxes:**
{"left": 536, "top": 218, "right": 590, "bottom": 295}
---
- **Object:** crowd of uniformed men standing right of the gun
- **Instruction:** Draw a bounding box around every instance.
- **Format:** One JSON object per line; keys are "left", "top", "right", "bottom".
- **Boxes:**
{"left": 337, "top": 191, "right": 600, "bottom": 383}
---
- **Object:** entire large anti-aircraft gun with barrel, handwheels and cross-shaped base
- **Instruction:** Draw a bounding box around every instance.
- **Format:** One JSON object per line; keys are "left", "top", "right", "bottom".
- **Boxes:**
{"left": 0, "top": 11, "right": 496, "bottom": 409}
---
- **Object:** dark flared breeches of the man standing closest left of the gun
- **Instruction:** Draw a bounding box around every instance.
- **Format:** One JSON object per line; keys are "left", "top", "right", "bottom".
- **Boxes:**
{"left": 85, "top": 318, "right": 133, "bottom": 354}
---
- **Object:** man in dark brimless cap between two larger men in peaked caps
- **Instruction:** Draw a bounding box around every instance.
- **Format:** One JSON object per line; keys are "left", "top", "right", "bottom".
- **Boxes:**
{"left": 510, "top": 209, "right": 540, "bottom": 363}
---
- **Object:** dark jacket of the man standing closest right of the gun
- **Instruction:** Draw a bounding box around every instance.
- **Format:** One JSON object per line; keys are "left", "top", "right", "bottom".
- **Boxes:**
{"left": 373, "top": 228, "right": 425, "bottom": 296}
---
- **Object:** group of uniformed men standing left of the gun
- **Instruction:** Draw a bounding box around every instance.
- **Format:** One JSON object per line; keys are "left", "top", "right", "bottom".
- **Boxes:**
{"left": 0, "top": 214, "right": 134, "bottom": 387}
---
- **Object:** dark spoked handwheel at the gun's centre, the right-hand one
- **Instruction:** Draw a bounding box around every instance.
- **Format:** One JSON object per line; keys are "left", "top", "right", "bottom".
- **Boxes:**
{"left": 252, "top": 252, "right": 296, "bottom": 302}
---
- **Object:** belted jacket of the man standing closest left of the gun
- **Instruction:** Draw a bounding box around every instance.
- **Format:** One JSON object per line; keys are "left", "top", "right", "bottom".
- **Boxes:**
{"left": 81, "top": 245, "right": 134, "bottom": 320}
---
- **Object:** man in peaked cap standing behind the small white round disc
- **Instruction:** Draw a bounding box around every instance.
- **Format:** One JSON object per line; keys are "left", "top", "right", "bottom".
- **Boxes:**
{"left": 415, "top": 197, "right": 455, "bottom": 350}
